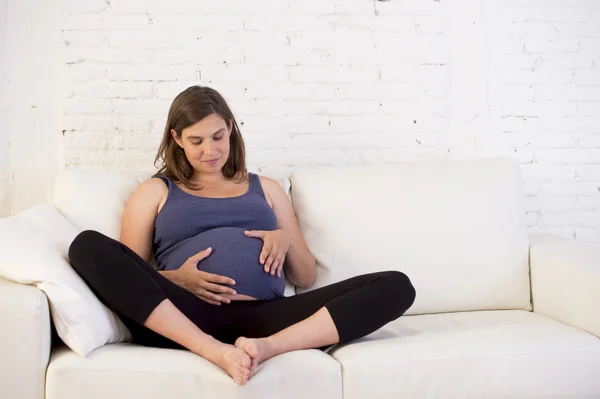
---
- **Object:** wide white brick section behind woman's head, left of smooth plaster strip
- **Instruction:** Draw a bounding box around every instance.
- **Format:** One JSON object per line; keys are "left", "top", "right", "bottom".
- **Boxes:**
{"left": 61, "top": 0, "right": 448, "bottom": 180}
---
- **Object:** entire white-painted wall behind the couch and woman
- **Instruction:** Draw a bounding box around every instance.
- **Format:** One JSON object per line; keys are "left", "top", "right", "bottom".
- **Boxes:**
{"left": 0, "top": 0, "right": 600, "bottom": 244}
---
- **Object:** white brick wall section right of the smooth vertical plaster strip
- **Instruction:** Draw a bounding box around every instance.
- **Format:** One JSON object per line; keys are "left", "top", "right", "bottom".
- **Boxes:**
{"left": 486, "top": 0, "right": 600, "bottom": 244}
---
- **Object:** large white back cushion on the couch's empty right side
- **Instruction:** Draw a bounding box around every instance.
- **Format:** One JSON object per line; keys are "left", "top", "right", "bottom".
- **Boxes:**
{"left": 291, "top": 159, "right": 530, "bottom": 314}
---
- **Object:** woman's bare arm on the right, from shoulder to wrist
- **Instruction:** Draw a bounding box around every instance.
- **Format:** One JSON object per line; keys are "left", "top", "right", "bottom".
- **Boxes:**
{"left": 260, "top": 176, "right": 317, "bottom": 288}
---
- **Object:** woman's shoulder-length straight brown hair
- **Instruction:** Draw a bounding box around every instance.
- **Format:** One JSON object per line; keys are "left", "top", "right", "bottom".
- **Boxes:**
{"left": 154, "top": 85, "right": 248, "bottom": 190}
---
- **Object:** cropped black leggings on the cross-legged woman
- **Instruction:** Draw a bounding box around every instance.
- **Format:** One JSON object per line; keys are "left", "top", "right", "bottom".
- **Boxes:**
{"left": 69, "top": 230, "right": 415, "bottom": 348}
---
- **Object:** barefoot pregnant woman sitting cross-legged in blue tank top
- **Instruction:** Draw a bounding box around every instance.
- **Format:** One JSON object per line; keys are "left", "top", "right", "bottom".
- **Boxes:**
{"left": 69, "top": 86, "right": 415, "bottom": 384}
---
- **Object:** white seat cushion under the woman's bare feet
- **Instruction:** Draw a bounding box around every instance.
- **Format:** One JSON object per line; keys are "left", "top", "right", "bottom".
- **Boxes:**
{"left": 46, "top": 344, "right": 342, "bottom": 399}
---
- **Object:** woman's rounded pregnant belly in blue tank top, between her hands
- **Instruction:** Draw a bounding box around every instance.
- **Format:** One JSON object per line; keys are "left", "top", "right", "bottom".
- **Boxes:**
{"left": 165, "top": 227, "right": 285, "bottom": 299}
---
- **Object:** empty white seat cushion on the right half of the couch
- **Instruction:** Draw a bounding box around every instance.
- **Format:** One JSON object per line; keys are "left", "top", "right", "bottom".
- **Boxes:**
{"left": 331, "top": 310, "right": 600, "bottom": 399}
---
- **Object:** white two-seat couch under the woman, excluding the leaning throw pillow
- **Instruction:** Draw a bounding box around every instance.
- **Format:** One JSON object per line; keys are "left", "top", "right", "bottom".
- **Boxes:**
{"left": 0, "top": 158, "right": 600, "bottom": 399}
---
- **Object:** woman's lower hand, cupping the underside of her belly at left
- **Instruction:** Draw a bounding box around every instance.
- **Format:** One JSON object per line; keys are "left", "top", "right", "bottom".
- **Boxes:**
{"left": 161, "top": 248, "right": 236, "bottom": 305}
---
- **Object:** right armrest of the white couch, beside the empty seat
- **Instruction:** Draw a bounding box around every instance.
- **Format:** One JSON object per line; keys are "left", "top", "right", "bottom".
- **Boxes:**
{"left": 529, "top": 235, "right": 600, "bottom": 337}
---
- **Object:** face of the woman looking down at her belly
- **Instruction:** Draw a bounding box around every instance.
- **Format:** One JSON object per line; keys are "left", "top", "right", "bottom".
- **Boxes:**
{"left": 171, "top": 114, "right": 231, "bottom": 174}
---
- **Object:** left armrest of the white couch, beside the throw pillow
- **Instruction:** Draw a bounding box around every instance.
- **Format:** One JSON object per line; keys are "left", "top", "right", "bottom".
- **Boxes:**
{"left": 0, "top": 278, "right": 51, "bottom": 399}
